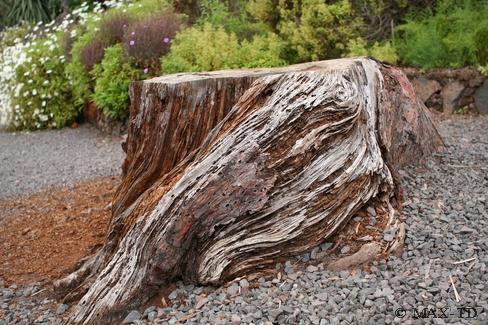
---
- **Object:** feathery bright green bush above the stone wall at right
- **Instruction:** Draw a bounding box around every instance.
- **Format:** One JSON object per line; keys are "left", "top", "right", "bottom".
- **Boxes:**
{"left": 397, "top": 0, "right": 488, "bottom": 69}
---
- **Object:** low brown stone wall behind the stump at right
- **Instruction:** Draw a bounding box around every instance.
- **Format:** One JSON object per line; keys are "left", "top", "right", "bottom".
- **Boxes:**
{"left": 403, "top": 68, "right": 488, "bottom": 114}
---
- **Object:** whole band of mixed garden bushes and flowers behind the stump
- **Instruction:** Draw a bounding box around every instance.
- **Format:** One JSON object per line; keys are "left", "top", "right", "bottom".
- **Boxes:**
{"left": 0, "top": 0, "right": 488, "bottom": 129}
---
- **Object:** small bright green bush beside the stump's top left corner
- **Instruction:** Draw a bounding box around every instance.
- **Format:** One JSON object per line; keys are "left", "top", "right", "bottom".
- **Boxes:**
{"left": 92, "top": 44, "right": 141, "bottom": 119}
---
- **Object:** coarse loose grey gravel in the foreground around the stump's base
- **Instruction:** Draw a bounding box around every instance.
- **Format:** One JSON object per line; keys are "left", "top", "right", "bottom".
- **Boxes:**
{"left": 0, "top": 117, "right": 488, "bottom": 325}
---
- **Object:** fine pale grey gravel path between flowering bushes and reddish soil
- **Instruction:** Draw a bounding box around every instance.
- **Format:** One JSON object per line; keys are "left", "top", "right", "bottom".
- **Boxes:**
{"left": 0, "top": 124, "right": 124, "bottom": 198}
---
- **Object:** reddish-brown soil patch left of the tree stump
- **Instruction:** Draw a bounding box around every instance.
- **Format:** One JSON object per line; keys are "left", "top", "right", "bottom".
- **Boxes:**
{"left": 0, "top": 177, "right": 119, "bottom": 285}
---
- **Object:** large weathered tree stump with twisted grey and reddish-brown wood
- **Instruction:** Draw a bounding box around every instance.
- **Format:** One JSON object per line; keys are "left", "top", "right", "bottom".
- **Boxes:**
{"left": 56, "top": 59, "right": 442, "bottom": 324}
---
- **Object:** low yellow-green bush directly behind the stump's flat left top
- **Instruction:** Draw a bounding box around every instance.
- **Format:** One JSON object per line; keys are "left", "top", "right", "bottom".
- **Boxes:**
{"left": 161, "top": 23, "right": 286, "bottom": 73}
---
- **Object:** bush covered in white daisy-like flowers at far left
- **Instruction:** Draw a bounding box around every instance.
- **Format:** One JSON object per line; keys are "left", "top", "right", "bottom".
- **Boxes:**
{"left": 0, "top": 1, "right": 119, "bottom": 129}
